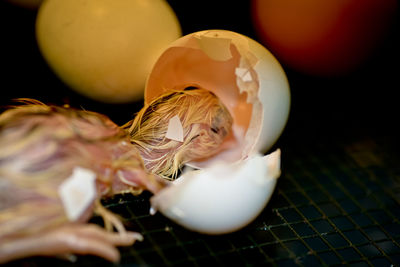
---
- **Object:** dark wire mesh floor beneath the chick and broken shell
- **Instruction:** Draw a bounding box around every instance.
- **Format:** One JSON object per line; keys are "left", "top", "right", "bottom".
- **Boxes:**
{"left": 5, "top": 138, "right": 400, "bottom": 266}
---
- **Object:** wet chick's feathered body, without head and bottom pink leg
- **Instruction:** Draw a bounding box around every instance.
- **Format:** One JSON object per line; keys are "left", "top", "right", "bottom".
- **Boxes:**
{"left": 0, "top": 99, "right": 163, "bottom": 262}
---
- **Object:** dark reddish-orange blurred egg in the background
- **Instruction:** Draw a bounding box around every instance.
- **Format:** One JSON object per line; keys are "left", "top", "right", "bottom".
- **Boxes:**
{"left": 252, "top": 0, "right": 397, "bottom": 76}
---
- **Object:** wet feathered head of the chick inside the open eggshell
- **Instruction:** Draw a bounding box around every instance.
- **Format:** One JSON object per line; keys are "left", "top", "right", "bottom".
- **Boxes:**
{"left": 123, "top": 87, "right": 233, "bottom": 179}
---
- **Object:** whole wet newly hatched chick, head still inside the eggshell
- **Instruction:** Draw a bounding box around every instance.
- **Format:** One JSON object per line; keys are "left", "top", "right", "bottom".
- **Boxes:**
{"left": 0, "top": 88, "right": 232, "bottom": 263}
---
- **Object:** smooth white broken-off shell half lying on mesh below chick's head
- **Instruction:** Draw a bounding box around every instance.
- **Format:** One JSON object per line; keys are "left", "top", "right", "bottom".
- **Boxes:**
{"left": 151, "top": 150, "right": 280, "bottom": 234}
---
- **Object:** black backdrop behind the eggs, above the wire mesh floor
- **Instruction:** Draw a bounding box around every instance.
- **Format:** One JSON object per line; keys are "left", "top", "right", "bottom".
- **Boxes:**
{"left": 0, "top": 0, "right": 400, "bottom": 147}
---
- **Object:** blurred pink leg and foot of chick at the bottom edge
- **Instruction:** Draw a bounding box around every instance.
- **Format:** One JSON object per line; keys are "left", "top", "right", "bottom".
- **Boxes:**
{"left": 0, "top": 224, "right": 143, "bottom": 263}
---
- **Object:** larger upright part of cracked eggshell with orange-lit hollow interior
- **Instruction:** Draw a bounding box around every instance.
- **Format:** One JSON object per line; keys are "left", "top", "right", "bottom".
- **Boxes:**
{"left": 145, "top": 30, "right": 290, "bottom": 168}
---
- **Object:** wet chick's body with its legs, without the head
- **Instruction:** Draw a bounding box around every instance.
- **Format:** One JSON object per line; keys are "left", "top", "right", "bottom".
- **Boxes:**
{"left": 0, "top": 100, "right": 163, "bottom": 263}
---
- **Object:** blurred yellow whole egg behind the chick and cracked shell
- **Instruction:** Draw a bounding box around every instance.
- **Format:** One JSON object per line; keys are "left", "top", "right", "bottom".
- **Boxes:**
{"left": 36, "top": 0, "right": 181, "bottom": 103}
